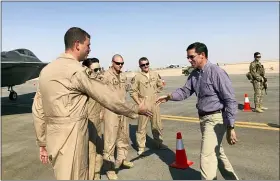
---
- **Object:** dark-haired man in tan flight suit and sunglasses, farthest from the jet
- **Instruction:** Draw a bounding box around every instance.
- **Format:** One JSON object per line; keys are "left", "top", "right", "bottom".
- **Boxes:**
{"left": 130, "top": 57, "right": 167, "bottom": 155}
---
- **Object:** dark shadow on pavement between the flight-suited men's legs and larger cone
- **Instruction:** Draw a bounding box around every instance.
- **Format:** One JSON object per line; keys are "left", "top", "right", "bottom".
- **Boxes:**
{"left": 129, "top": 125, "right": 201, "bottom": 180}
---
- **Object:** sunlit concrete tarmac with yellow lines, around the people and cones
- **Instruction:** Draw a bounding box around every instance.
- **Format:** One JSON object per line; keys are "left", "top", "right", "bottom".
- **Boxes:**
{"left": 1, "top": 74, "right": 279, "bottom": 180}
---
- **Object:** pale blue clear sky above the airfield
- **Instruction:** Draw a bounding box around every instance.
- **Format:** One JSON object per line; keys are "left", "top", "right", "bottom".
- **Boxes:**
{"left": 2, "top": 2, "right": 279, "bottom": 70}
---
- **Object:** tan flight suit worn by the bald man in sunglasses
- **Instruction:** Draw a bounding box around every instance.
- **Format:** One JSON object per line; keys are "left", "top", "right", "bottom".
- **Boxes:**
{"left": 103, "top": 68, "right": 129, "bottom": 174}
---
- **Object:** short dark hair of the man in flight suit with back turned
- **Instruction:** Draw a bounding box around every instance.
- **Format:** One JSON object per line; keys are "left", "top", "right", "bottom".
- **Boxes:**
{"left": 64, "top": 27, "right": 90, "bottom": 49}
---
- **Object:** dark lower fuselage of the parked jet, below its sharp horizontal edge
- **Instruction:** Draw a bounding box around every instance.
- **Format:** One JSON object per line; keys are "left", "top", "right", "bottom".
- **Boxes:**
{"left": 1, "top": 62, "right": 48, "bottom": 87}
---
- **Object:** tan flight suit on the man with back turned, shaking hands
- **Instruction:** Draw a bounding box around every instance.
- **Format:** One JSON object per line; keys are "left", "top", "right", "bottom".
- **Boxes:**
{"left": 32, "top": 53, "right": 138, "bottom": 180}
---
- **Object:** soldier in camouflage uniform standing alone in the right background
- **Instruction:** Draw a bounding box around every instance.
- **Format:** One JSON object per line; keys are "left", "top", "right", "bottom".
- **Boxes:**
{"left": 249, "top": 52, "right": 268, "bottom": 113}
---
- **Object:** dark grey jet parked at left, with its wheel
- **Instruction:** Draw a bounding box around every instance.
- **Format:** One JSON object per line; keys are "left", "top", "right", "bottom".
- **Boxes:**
{"left": 1, "top": 48, "right": 48, "bottom": 100}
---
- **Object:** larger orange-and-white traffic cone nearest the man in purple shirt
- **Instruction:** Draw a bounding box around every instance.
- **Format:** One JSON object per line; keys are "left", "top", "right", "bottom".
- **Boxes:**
{"left": 170, "top": 132, "right": 194, "bottom": 169}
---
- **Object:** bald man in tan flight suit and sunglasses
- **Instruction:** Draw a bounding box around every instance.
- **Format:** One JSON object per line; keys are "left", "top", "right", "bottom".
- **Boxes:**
{"left": 103, "top": 54, "right": 133, "bottom": 180}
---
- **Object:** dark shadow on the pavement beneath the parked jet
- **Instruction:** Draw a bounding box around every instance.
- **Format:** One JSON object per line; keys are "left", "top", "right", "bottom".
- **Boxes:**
{"left": 1, "top": 92, "right": 35, "bottom": 116}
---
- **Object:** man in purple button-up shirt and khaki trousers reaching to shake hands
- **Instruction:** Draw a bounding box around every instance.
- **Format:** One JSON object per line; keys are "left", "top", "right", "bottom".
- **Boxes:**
{"left": 157, "top": 42, "right": 238, "bottom": 180}
